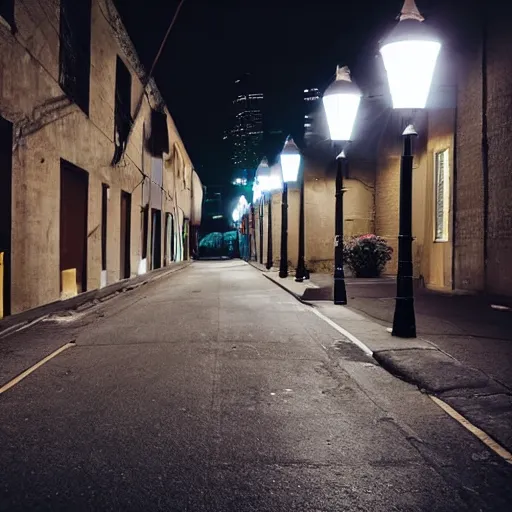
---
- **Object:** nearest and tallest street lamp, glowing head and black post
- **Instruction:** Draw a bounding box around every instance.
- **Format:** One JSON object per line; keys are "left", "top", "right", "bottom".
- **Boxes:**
{"left": 380, "top": 0, "right": 441, "bottom": 338}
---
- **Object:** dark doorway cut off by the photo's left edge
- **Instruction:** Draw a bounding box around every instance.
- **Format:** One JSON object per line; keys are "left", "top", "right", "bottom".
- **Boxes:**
{"left": 0, "top": 117, "right": 12, "bottom": 318}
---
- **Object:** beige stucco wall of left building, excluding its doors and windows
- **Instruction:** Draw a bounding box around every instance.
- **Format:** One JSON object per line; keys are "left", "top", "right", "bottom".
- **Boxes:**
{"left": 0, "top": 0, "right": 196, "bottom": 313}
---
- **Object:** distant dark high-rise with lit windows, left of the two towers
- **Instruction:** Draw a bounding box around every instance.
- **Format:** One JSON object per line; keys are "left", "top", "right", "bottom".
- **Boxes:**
{"left": 227, "top": 73, "right": 263, "bottom": 181}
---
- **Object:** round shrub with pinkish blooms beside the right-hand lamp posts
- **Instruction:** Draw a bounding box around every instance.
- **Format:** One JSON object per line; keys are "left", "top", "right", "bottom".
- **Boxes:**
{"left": 343, "top": 234, "right": 393, "bottom": 277}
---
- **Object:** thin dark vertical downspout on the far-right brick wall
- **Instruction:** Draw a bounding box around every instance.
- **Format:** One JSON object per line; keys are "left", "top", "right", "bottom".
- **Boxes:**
{"left": 481, "top": 3, "right": 489, "bottom": 292}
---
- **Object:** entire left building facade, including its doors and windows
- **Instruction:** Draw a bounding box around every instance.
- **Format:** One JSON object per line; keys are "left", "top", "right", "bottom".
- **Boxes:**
{"left": 0, "top": 0, "right": 202, "bottom": 315}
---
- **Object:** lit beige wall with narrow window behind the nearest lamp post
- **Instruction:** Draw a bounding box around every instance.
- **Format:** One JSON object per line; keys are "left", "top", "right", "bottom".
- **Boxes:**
{"left": 375, "top": 109, "right": 455, "bottom": 290}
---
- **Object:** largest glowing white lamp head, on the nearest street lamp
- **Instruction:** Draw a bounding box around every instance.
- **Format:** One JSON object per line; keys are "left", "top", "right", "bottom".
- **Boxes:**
{"left": 380, "top": 0, "right": 441, "bottom": 109}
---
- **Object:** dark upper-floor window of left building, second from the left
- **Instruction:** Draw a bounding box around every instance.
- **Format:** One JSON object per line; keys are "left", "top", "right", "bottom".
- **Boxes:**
{"left": 112, "top": 56, "right": 132, "bottom": 165}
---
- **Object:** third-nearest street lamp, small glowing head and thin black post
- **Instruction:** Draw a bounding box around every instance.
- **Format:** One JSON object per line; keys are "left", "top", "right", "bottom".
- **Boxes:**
{"left": 279, "top": 136, "right": 300, "bottom": 278}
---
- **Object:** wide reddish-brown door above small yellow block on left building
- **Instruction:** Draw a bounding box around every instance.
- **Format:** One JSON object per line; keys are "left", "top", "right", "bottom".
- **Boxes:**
{"left": 60, "top": 160, "right": 89, "bottom": 293}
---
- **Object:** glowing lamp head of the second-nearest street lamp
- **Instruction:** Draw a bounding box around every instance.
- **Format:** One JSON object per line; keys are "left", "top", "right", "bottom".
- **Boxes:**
{"left": 323, "top": 66, "right": 362, "bottom": 141}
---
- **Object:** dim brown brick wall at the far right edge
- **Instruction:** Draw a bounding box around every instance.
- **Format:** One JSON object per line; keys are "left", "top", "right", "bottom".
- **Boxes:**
{"left": 455, "top": 3, "right": 512, "bottom": 296}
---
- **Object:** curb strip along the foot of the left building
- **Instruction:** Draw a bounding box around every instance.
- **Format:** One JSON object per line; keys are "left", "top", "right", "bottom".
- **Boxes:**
{"left": 0, "top": 261, "right": 192, "bottom": 339}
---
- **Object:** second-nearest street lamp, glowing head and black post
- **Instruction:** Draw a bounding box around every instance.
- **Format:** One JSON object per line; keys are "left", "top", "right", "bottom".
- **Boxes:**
{"left": 323, "top": 66, "right": 362, "bottom": 305}
